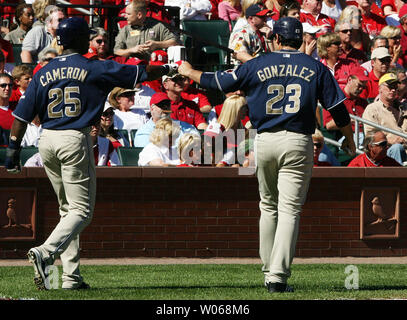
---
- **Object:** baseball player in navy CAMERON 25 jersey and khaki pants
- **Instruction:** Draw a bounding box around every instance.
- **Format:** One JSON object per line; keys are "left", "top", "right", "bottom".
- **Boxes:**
{"left": 6, "top": 17, "right": 177, "bottom": 289}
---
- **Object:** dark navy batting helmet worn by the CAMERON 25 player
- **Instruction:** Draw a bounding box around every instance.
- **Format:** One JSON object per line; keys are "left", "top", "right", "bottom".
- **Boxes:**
{"left": 57, "top": 17, "right": 90, "bottom": 49}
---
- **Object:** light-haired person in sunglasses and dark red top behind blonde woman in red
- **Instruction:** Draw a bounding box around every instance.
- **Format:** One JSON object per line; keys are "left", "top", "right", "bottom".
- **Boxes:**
{"left": 335, "top": 20, "right": 367, "bottom": 64}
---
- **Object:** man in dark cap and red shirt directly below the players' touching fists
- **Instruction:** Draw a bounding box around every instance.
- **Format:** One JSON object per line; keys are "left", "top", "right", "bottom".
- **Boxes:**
{"left": 162, "top": 74, "right": 208, "bottom": 130}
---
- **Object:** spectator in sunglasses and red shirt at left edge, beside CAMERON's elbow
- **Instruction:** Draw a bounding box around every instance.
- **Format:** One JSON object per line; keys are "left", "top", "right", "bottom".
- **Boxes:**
{"left": 0, "top": 73, "right": 16, "bottom": 130}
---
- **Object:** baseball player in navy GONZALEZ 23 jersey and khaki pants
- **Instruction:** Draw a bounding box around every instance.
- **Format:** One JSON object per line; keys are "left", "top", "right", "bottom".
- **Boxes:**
{"left": 178, "top": 17, "right": 356, "bottom": 293}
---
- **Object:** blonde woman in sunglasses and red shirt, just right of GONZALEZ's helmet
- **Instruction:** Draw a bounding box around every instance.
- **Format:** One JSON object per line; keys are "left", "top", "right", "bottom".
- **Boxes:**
{"left": 317, "top": 33, "right": 358, "bottom": 89}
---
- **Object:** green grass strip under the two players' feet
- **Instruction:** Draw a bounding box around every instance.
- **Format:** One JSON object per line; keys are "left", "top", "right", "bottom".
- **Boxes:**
{"left": 0, "top": 264, "right": 407, "bottom": 300}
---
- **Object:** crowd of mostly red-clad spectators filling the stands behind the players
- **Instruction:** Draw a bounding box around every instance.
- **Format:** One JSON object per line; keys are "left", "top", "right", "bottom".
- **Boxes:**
{"left": 0, "top": 0, "right": 407, "bottom": 167}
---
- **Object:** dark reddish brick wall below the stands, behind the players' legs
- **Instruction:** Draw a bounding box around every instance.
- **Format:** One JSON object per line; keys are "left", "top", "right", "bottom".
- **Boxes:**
{"left": 0, "top": 168, "right": 407, "bottom": 258}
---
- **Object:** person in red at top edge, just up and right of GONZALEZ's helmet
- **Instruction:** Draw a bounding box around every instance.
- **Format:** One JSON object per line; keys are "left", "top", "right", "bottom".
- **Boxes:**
{"left": 300, "top": 0, "right": 336, "bottom": 35}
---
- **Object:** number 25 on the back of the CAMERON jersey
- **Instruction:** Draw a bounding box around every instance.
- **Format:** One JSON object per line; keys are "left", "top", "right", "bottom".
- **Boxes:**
{"left": 48, "top": 86, "right": 81, "bottom": 119}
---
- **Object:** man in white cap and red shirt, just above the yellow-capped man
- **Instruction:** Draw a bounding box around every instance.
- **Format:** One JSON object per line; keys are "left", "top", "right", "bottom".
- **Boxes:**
{"left": 361, "top": 47, "right": 391, "bottom": 99}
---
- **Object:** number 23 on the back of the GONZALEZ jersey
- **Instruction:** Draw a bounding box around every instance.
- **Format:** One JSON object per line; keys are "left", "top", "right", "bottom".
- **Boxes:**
{"left": 266, "top": 83, "right": 301, "bottom": 115}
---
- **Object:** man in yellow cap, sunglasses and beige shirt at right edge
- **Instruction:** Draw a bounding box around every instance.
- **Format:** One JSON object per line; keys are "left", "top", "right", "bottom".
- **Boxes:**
{"left": 363, "top": 73, "right": 407, "bottom": 164}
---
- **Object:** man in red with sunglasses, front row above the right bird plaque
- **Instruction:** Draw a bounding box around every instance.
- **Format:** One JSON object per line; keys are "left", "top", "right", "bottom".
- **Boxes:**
{"left": 348, "top": 131, "right": 400, "bottom": 167}
